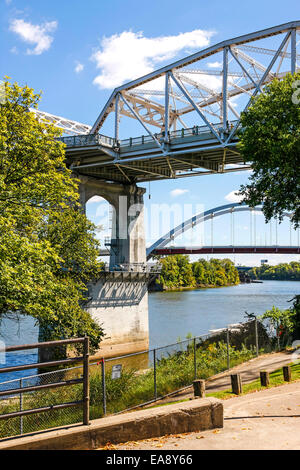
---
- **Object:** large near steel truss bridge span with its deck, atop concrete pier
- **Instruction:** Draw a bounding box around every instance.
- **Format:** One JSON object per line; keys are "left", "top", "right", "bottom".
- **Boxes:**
{"left": 31, "top": 21, "right": 300, "bottom": 184}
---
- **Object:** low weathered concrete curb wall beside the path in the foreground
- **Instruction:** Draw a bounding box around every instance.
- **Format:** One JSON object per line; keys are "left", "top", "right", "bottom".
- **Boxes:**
{"left": 0, "top": 398, "right": 223, "bottom": 450}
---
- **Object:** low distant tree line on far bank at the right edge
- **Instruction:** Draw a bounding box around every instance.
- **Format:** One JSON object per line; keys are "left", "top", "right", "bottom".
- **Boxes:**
{"left": 249, "top": 261, "right": 300, "bottom": 281}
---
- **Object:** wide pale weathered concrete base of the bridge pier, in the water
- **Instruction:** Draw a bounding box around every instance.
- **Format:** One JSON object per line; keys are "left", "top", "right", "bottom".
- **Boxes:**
{"left": 86, "top": 280, "right": 149, "bottom": 357}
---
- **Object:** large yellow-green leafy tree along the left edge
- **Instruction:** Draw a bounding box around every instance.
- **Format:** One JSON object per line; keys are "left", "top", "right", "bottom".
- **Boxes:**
{"left": 0, "top": 79, "right": 103, "bottom": 350}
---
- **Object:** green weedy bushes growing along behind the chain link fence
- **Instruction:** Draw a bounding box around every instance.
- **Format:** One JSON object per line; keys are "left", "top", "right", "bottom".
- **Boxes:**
{"left": 99, "top": 342, "right": 256, "bottom": 413}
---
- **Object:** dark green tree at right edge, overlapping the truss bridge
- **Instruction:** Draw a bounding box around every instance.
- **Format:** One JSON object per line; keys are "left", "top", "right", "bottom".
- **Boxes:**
{"left": 238, "top": 73, "right": 300, "bottom": 227}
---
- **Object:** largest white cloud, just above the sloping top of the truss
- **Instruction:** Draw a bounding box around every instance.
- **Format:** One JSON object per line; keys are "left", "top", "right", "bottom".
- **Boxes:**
{"left": 91, "top": 29, "right": 214, "bottom": 88}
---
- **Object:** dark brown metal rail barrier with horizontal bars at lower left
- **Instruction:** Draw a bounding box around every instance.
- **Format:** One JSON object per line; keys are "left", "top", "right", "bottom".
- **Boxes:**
{"left": 0, "top": 337, "right": 90, "bottom": 434}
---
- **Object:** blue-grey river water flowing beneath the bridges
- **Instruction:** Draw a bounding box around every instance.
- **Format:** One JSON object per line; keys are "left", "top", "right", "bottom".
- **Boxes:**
{"left": 0, "top": 281, "right": 300, "bottom": 382}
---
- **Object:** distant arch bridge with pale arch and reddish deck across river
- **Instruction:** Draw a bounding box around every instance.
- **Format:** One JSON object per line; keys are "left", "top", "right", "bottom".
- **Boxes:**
{"left": 147, "top": 203, "right": 300, "bottom": 259}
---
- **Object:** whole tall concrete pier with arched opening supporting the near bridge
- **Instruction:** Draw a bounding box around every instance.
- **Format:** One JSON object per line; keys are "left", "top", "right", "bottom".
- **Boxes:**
{"left": 79, "top": 177, "right": 150, "bottom": 357}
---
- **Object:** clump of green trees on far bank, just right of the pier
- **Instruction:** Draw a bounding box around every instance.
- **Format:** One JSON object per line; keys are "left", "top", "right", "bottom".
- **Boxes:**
{"left": 156, "top": 255, "right": 239, "bottom": 290}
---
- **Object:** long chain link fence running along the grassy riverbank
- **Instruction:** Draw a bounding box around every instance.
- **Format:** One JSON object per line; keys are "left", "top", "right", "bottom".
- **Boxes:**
{"left": 0, "top": 319, "right": 292, "bottom": 438}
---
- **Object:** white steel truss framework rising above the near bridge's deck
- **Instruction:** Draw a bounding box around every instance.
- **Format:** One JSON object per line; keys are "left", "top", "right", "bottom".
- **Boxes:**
{"left": 89, "top": 21, "right": 300, "bottom": 145}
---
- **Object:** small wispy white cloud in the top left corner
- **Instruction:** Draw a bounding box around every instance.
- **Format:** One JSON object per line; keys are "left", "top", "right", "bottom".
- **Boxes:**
{"left": 9, "top": 19, "right": 57, "bottom": 55}
